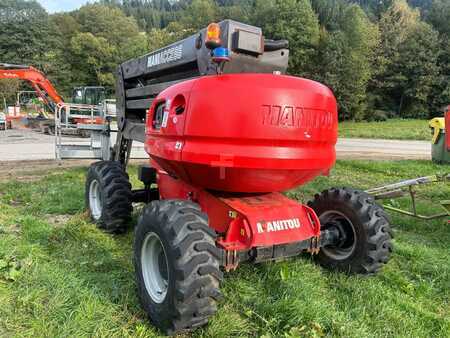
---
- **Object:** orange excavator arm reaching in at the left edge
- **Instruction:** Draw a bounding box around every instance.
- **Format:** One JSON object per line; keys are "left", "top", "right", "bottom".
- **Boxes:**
{"left": 0, "top": 63, "right": 64, "bottom": 110}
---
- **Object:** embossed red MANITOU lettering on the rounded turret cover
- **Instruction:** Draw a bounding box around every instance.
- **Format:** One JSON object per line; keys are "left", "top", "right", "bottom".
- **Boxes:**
{"left": 261, "top": 105, "right": 334, "bottom": 129}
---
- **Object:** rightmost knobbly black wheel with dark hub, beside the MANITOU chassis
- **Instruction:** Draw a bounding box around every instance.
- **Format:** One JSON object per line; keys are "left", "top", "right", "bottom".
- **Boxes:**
{"left": 308, "top": 188, "right": 393, "bottom": 274}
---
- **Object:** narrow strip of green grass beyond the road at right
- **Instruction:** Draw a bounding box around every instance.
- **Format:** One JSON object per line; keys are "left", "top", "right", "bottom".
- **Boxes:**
{"left": 339, "top": 119, "right": 431, "bottom": 141}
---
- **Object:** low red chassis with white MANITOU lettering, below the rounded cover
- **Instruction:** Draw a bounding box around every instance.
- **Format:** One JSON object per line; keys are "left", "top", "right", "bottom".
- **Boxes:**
{"left": 158, "top": 172, "right": 320, "bottom": 251}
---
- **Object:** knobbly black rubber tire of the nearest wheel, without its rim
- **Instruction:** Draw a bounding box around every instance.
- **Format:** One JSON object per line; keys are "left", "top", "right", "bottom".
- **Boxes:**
{"left": 135, "top": 200, "right": 223, "bottom": 334}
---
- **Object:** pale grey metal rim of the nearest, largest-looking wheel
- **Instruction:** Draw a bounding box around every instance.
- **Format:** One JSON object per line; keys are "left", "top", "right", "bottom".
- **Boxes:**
{"left": 141, "top": 232, "right": 169, "bottom": 303}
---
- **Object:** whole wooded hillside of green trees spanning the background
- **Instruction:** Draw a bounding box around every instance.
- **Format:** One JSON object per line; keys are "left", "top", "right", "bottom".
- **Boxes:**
{"left": 0, "top": 0, "right": 450, "bottom": 119}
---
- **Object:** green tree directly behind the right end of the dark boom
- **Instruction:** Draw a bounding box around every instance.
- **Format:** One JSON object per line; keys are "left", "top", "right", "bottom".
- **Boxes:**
{"left": 253, "top": 0, "right": 319, "bottom": 77}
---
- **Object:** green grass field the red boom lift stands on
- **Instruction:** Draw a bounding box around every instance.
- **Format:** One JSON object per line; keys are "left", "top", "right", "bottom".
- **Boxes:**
{"left": 0, "top": 161, "right": 450, "bottom": 338}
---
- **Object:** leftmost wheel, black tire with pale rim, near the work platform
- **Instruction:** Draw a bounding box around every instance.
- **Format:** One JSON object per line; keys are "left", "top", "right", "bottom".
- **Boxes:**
{"left": 85, "top": 161, "right": 133, "bottom": 233}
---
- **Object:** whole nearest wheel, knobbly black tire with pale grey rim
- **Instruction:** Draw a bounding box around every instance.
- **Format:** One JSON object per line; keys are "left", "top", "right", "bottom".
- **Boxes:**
{"left": 134, "top": 200, "right": 222, "bottom": 335}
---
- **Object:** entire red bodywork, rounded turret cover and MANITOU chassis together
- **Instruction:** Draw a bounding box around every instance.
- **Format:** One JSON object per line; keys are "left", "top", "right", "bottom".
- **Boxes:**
{"left": 145, "top": 74, "right": 337, "bottom": 254}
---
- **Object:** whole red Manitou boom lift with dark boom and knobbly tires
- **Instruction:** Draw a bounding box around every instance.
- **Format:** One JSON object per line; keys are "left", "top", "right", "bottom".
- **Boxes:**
{"left": 86, "top": 20, "right": 392, "bottom": 334}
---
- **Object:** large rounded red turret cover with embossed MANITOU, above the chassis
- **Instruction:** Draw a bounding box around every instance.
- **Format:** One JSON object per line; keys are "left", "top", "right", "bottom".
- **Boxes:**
{"left": 145, "top": 74, "right": 337, "bottom": 193}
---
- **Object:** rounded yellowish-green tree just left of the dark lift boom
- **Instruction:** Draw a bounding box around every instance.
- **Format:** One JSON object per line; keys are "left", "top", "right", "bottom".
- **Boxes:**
{"left": 64, "top": 4, "right": 148, "bottom": 88}
